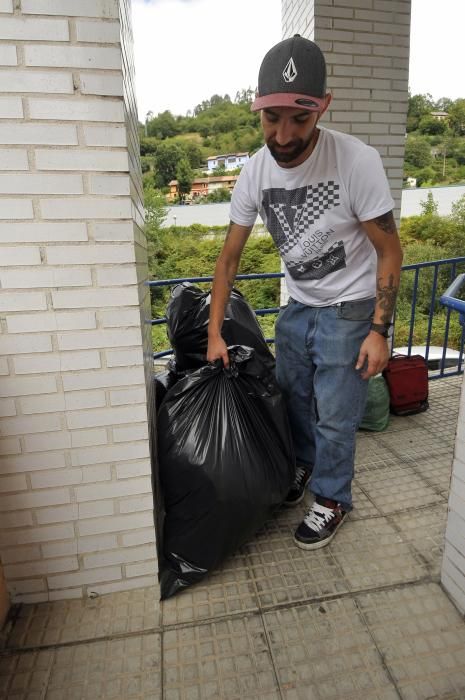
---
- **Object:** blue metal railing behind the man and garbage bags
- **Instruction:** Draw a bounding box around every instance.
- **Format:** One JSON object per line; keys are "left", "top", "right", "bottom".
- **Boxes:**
{"left": 148, "top": 256, "right": 465, "bottom": 379}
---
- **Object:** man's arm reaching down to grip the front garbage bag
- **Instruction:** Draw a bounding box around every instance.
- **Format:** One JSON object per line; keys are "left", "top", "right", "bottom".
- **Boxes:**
{"left": 207, "top": 221, "right": 252, "bottom": 367}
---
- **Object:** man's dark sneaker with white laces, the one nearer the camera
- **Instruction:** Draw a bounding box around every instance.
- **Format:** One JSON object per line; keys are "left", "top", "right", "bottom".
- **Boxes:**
{"left": 294, "top": 496, "right": 347, "bottom": 549}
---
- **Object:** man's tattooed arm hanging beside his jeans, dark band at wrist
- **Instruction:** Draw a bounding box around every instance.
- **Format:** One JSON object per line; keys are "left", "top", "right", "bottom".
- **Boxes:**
{"left": 357, "top": 211, "right": 402, "bottom": 379}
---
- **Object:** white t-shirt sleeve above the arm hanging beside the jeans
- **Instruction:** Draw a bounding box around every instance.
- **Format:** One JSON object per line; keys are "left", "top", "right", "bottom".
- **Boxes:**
{"left": 349, "top": 146, "right": 395, "bottom": 221}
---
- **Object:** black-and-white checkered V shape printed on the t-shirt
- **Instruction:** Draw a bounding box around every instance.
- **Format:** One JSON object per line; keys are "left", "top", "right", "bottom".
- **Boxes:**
{"left": 273, "top": 180, "right": 339, "bottom": 255}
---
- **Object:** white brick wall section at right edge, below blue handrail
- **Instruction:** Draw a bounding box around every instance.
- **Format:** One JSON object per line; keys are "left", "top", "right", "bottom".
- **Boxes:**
{"left": 441, "top": 383, "right": 465, "bottom": 615}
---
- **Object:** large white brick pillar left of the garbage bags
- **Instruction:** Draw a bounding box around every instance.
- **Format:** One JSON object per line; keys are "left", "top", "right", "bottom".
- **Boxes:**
{"left": 0, "top": 0, "right": 157, "bottom": 602}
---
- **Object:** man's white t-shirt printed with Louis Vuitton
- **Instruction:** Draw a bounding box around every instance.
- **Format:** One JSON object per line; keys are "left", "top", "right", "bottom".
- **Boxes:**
{"left": 230, "top": 128, "right": 394, "bottom": 306}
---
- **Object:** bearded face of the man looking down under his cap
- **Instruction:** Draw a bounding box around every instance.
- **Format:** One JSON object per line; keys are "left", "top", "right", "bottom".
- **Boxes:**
{"left": 261, "top": 107, "right": 321, "bottom": 168}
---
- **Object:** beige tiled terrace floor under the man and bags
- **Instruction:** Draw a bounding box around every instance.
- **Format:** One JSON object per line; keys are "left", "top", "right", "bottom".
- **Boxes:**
{"left": 0, "top": 378, "right": 465, "bottom": 700}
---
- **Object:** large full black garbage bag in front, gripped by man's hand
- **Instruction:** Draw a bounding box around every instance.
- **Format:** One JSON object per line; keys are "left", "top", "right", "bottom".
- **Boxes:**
{"left": 158, "top": 346, "right": 295, "bottom": 599}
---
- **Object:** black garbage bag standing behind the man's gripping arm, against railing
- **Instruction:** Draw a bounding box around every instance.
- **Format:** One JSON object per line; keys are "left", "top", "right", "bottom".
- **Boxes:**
{"left": 166, "top": 282, "right": 275, "bottom": 371}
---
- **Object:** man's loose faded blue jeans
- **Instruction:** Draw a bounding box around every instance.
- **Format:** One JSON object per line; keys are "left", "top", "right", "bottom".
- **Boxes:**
{"left": 275, "top": 298, "right": 375, "bottom": 511}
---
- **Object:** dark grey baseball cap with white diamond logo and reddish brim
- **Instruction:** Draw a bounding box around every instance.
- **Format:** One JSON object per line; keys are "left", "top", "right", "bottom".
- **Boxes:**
{"left": 251, "top": 34, "right": 326, "bottom": 112}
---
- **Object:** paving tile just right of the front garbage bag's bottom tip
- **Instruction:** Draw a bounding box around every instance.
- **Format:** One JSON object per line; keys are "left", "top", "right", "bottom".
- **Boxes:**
{"left": 161, "top": 553, "right": 258, "bottom": 626}
